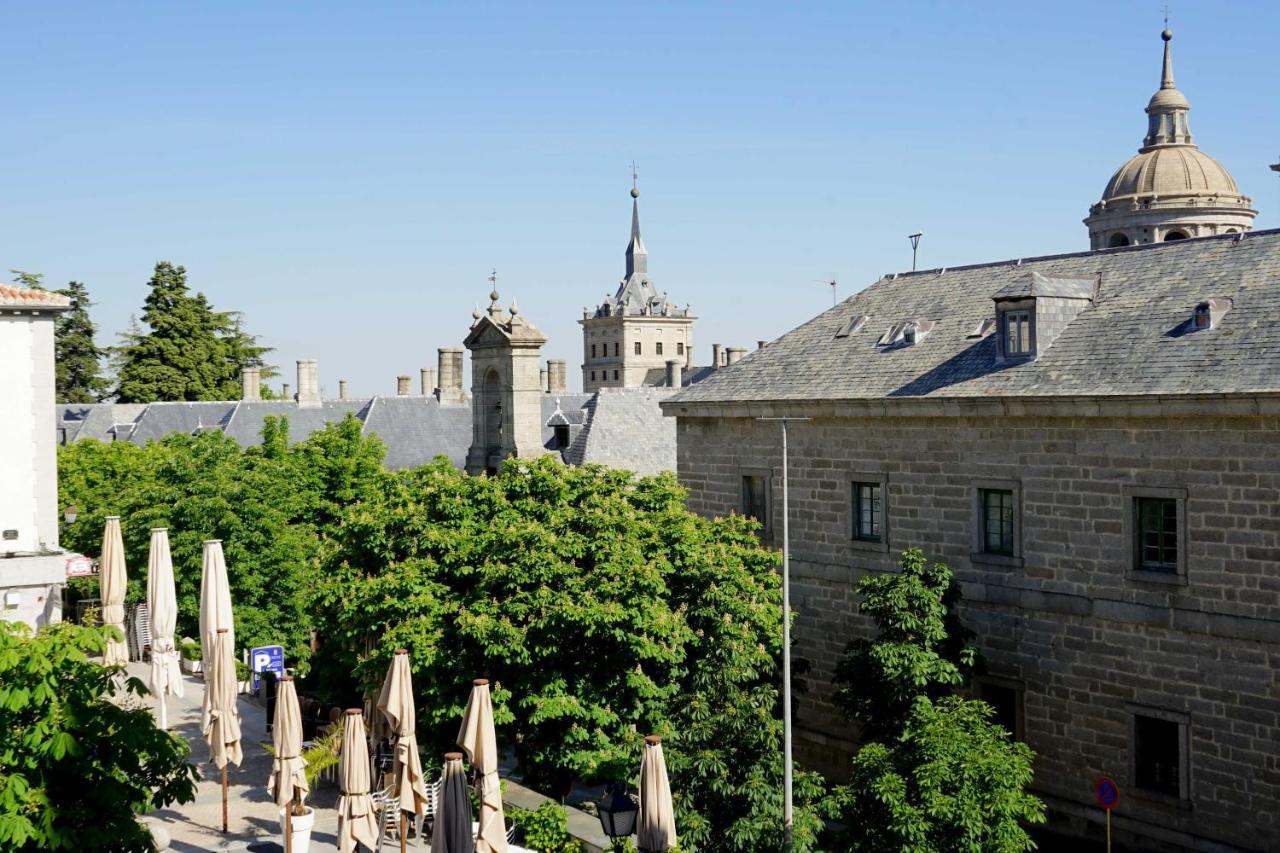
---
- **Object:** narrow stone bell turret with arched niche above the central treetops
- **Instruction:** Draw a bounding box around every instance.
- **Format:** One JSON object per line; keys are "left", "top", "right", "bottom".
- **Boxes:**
{"left": 463, "top": 288, "right": 547, "bottom": 474}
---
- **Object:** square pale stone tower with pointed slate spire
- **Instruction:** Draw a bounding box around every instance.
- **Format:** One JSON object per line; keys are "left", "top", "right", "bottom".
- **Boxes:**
{"left": 581, "top": 181, "right": 696, "bottom": 393}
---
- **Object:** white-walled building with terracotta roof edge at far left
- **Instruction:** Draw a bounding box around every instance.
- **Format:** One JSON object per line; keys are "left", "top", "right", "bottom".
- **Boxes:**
{"left": 0, "top": 284, "right": 70, "bottom": 628}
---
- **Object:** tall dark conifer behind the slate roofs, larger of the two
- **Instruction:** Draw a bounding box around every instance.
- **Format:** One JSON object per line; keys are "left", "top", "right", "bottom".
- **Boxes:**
{"left": 116, "top": 261, "right": 269, "bottom": 402}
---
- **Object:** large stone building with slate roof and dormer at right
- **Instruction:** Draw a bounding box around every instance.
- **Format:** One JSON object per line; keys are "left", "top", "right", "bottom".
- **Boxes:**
{"left": 663, "top": 231, "right": 1280, "bottom": 850}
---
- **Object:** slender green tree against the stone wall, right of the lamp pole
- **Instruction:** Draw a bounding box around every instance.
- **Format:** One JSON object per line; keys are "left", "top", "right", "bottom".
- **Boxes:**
{"left": 828, "top": 548, "right": 1044, "bottom": 853}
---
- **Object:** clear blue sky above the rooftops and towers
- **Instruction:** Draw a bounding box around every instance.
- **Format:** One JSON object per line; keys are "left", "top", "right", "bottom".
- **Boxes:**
{"left": 0, "top": 0, "right": 1280, "bottom": 394}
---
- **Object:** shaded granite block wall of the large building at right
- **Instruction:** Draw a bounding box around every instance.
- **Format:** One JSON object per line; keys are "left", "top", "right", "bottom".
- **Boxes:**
{"left": 677, "top": 416, "right": 1280, "bottom": 849}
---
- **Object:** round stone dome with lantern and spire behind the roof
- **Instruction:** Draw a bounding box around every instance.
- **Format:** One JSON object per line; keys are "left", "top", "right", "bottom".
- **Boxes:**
{"left": 1084, "top": 29, "right": 1258, "bottom": 248}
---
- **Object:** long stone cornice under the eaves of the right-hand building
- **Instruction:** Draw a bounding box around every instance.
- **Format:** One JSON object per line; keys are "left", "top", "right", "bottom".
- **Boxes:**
{"left": 660, "top": 392, "right": 1280, "bottom": 418}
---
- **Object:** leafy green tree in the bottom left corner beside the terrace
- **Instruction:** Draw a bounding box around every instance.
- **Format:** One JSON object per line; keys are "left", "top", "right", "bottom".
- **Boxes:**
{"left": 0, "top": 620, "right": 196, "bottom": 850}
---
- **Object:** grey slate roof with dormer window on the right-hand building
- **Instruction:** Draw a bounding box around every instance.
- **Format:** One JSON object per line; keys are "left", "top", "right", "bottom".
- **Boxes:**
{"left": 672, "top": 231, "right": 1280, "bottom": 403}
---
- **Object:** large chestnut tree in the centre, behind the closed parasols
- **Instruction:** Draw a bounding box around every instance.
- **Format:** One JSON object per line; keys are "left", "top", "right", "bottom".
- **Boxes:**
{"left": 316, "top": 459, "right": 820, "bottom": 850}
